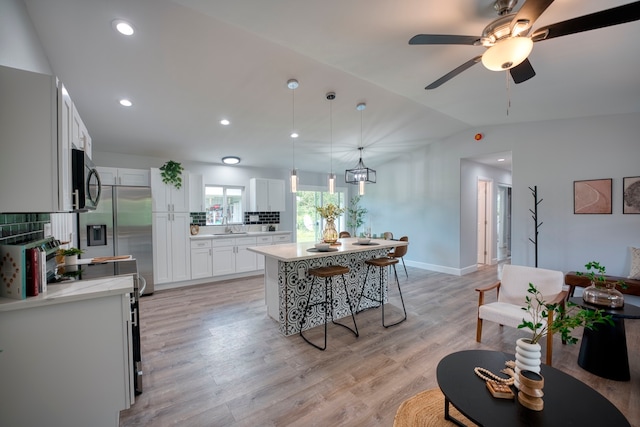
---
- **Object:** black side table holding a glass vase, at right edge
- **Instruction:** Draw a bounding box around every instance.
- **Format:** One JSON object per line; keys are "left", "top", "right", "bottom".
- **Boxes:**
{"left": 569, "top": 297, "right": 640, "bottom": 381}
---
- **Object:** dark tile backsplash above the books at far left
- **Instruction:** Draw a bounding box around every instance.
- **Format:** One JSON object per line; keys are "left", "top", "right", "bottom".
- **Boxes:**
{"left": 0, "top": 213, "right": 51, "bottom": 245}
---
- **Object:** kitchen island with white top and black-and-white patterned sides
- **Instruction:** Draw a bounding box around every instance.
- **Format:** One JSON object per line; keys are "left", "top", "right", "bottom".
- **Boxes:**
{"left": 248, "top": 238, "right": 408, "bottom": 336}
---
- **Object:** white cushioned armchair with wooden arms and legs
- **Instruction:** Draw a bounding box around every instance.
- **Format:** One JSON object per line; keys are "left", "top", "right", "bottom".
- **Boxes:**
{"left": 476, "top": 264, "right": 567, "bottom": 366}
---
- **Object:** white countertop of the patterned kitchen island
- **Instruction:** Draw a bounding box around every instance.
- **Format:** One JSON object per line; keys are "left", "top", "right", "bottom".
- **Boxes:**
{"left": 247, "top": 237, "right": 409, "bottom": 262}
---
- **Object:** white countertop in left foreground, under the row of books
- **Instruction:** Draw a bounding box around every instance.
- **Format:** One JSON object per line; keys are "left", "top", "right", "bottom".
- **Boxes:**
{"left": 0, "top": 276, "right": 133, "bottom": 312}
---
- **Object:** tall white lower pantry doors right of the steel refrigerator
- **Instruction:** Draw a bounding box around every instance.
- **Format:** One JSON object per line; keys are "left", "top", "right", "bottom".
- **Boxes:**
{"left": 152, "top": 212, "right": 191, "bottom": 284}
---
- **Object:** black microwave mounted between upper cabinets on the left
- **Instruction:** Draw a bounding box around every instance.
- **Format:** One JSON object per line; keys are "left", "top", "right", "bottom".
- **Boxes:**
{"left": 71, "top": 148, "right": 102, "bottom": 212}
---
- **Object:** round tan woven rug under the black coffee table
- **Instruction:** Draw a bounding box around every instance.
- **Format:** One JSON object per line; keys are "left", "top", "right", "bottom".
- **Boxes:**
{"left": 393, "top": 388, "right": 474, "bottom": 427}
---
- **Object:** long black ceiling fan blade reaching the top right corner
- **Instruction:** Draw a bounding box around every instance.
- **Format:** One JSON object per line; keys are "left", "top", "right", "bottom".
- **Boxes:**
{"left": 531, "top": 1, "right": 640, "bottom": 42}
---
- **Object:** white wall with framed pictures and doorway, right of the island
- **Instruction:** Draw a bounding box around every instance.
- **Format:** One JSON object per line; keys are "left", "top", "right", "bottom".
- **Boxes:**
{"left": 363, "top": 113, "right": 640, "bottom": 275}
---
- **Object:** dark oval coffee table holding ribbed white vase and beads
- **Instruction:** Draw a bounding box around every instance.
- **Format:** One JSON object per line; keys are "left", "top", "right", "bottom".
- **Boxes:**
{"left": 437, "top": 350, "right": 630, "bottom": 427}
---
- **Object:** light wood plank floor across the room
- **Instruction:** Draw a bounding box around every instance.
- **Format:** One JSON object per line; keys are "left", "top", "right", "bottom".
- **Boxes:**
{"left": 120, "top": 267, "right": 640, "bottom": 427}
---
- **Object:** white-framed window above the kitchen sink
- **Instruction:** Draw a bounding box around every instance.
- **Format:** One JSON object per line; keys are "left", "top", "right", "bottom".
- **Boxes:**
{"left": 204, "top": 185, "right": 244, "bottom": 225}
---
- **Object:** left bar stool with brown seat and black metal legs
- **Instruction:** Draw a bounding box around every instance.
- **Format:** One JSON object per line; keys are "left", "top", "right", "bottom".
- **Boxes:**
{"left": 300, "top": 265, "right": 359, "bottom": 350}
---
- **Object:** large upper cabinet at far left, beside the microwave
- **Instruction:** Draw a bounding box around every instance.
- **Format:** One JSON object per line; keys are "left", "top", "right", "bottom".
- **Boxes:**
{"left": 0, "top": 66, "right": 66, "bottom": 213}
